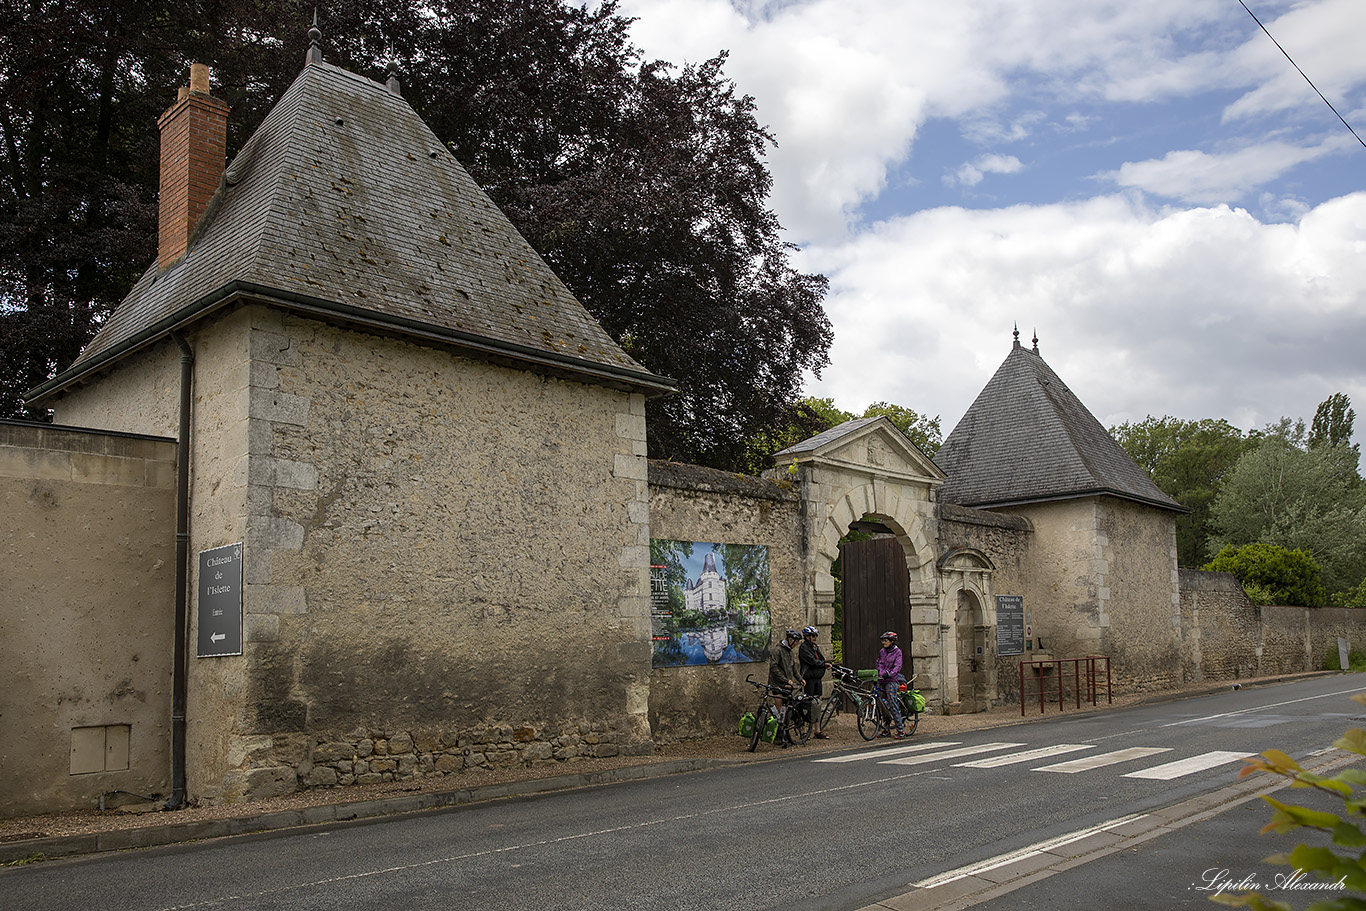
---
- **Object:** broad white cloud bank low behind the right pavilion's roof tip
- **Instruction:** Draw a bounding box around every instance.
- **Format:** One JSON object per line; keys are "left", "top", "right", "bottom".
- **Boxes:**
{"left": 803, "top": 193, "right": 1366, "bottom": 447}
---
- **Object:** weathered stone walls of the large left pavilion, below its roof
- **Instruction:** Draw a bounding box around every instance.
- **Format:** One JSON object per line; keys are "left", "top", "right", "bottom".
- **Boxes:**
{"left": 50, "top": 306, "right": 653, "bottom": 802}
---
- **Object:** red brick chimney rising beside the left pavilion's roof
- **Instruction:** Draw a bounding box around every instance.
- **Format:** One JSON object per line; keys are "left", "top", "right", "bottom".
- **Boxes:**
{"left": 157, "top": 63, "right": 228, "bottom": 269}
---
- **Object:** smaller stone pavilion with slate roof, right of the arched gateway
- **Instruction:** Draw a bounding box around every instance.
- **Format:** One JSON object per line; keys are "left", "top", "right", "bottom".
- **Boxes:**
{"left": 934, "top": 331, "right": 1184, "bottom": 687}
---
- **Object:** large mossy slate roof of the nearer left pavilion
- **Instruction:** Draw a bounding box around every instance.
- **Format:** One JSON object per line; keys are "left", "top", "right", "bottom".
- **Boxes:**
{"left": 30, "top": 59, "right": 673, "bottom": 399}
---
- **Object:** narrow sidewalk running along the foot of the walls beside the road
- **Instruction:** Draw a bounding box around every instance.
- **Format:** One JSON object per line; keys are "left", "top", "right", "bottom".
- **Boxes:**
{"left": 0, "top": 671, "right": 1338, "bottom": 865}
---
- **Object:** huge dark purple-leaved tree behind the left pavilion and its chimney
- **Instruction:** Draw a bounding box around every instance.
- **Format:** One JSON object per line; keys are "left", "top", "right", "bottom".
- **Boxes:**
{"left": 0, "top": 0, "right": 832, "bottom": 467}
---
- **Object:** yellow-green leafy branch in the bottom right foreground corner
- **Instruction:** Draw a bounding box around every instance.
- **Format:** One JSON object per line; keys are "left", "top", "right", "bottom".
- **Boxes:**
{"left": 1210, "top": 692, "right": 1366, "bottom": 911}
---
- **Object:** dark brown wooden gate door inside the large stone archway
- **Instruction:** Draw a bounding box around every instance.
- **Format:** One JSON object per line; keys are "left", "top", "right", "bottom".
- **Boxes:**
{"left": 840, "top": 538, "right": 911, "bottom": 677}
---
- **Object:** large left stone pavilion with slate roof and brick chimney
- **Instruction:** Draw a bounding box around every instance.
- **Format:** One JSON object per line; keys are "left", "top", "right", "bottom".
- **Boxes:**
{"left": 31, "top": 35, "right": 672, "bottom": 802}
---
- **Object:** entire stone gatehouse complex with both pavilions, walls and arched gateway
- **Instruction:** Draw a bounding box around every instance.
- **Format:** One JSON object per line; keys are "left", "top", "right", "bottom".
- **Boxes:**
{"left": 0, "top": 46, "right": 1360, "bottom": 815}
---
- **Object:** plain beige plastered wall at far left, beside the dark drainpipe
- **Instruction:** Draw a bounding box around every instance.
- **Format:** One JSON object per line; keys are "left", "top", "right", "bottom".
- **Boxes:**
{"left": 0, "top": 422, "right": 176, "bottom": 815}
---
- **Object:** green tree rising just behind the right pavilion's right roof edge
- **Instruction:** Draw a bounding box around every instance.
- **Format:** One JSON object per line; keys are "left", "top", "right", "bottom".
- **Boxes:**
{"left": 1111, "top": 415, "right": 1251, "bottom": 565}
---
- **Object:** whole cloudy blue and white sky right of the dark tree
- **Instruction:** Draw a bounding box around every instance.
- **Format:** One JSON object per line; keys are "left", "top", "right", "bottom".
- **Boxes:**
{"left": 622, "top": 0, "right": 1366, "bottom": 441}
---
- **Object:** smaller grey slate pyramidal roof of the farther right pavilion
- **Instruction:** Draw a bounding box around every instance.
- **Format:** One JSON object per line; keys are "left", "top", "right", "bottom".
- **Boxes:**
{"left": 934, "top": 340, "right": 1187, "bottom": 512}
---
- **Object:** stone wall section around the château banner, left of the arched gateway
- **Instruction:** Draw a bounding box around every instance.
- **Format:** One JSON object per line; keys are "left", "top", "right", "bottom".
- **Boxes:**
{"left": 649, "top": 462, "right": 803, "bottom": 743}
